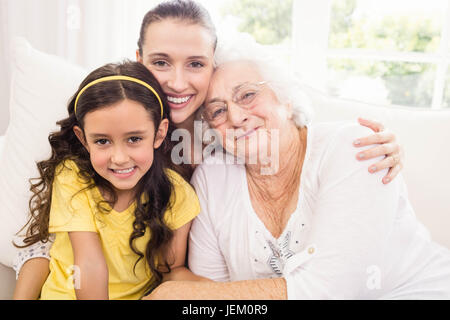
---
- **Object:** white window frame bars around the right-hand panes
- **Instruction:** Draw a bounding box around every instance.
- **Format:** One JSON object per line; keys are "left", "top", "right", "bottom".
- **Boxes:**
{"left": 292, "top": 0, "right": 450, "bottom": 109}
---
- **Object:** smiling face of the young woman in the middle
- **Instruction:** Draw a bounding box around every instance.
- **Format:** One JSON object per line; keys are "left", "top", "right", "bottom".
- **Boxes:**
{"left": 136, "top": 19, "right": 214, "bottom": 127}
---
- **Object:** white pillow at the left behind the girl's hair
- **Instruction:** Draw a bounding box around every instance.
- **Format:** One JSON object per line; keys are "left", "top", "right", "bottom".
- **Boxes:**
{"left": 0, "top": 38, "right": 87, "bottom": 266}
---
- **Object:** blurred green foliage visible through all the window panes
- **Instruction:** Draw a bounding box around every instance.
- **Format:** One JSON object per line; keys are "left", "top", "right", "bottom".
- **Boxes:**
{"left": 222, "top": 0, "right": 450, "bottom": 107}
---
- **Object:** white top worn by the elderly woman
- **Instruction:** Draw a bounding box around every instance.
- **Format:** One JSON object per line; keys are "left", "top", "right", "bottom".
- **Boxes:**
{"left": 189, "top": 122, "right": 450, "bottom": 299}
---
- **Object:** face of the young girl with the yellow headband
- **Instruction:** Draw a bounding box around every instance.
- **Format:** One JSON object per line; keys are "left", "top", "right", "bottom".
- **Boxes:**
{"left": 74, "top": 100, "right": 169, "bottom": 194}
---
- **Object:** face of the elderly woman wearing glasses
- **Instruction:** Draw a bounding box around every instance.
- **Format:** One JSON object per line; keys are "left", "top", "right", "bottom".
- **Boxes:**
{"left": 203, "top": 61, "right": 290, "bottom": 163}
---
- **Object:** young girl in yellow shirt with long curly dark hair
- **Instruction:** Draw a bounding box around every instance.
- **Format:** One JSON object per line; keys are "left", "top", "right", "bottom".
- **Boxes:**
{"left": 17, "top": 62, "right": 200, "bottom": 299}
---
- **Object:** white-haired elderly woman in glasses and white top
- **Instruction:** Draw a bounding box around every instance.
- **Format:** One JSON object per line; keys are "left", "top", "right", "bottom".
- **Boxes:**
{"left": 148, "top": 43, "right": 450, "bottom": 299}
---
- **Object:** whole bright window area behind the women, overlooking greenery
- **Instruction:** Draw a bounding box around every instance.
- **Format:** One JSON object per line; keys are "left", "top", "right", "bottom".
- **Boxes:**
{"left": 221, "top": 0, "right": 450, "bottom": 109}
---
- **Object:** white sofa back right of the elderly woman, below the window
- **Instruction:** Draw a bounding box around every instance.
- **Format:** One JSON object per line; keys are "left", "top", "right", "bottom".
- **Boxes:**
{"left": 305, "top": 88, "right": 450, "bottom": 248}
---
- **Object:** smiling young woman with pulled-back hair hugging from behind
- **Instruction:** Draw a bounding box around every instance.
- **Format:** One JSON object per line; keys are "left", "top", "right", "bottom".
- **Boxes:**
{"left": 15, "top": 1, "right": 402, "bottom": 298}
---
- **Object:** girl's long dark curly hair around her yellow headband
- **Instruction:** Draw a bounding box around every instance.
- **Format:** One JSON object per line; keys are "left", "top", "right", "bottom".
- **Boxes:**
{"left": 16, "top": 61, "right": 184, "bottom": 290}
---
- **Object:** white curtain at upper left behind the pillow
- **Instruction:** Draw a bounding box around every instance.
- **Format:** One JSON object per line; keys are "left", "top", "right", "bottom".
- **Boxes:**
{"left": 0, "top": 0, "right": 160, "bottom": 135}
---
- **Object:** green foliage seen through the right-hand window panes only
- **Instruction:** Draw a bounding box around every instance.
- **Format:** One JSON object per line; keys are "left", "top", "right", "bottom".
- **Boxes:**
{"left": 328, "top": 0, "right": 442, "bottom": 107}
